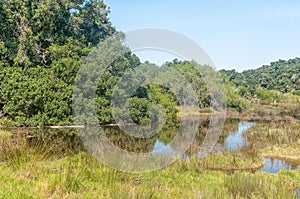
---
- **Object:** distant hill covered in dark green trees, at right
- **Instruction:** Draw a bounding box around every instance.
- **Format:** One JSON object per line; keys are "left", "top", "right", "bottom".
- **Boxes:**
{"left": 221, "top": 58, "right": 300, "bottom": 95}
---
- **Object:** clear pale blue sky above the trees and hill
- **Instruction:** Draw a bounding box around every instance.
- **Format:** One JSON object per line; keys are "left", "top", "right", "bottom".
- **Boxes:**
{"left": 104, "top": 0, "right": 300, "bottom": 71}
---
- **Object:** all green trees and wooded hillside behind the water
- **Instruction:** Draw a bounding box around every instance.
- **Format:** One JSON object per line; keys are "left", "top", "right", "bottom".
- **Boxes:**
{"left": 0, "top": 0, "right": 300, "bottom": 126}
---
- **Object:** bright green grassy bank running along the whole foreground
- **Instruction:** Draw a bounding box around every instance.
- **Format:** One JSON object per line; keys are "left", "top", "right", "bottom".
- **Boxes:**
{"left": 0, "top": 133, "right": 300, "bottom": 198}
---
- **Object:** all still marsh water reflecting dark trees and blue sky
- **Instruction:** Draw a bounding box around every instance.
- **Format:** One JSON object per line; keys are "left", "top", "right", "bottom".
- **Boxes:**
{"left": 24, "top": 120, "right": 300, "bottom": 173}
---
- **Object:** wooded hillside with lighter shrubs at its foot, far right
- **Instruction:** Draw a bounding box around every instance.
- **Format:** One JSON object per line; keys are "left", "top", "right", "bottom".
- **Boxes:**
{"left": 220, "top": 58, "right": 300, "bottom": 111}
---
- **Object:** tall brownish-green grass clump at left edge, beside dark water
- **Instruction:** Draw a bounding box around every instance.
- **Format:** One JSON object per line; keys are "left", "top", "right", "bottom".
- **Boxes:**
{"left": 0, "top": 129, "right": 83, "bottom": 169}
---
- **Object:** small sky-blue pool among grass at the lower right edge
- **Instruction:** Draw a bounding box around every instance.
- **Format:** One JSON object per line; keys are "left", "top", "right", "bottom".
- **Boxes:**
{"left": 260, "top": 158, "right": 300, "bottom": 173}
